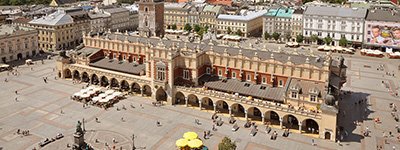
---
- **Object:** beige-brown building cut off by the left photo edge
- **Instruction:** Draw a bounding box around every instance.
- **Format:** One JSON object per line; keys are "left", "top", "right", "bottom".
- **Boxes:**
{"left": 0, "top": 25, "right": 39, "bottom": 63}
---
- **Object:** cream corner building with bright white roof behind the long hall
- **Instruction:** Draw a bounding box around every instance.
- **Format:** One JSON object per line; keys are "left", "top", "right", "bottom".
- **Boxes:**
{"left": 216, "top": 10, "right": 267, "bottom": 37}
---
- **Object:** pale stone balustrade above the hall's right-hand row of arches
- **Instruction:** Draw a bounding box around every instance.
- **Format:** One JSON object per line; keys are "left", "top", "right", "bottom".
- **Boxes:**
{"left": 176, "top": 86, "right": 321, "bottom": 119}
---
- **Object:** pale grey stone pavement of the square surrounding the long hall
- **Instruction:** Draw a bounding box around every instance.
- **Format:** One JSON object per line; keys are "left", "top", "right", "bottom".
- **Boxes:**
{"left": 0, "top": 53, "right": 400, "bottom": 150}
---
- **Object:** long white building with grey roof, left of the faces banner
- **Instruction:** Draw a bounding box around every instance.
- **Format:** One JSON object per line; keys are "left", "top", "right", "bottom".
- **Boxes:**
{"left": 303, "top": 6, "right": 367, "bottom": 46}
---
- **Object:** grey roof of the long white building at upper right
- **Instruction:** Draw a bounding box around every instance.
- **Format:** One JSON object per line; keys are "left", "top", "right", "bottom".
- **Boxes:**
{"left": 304, "top": 6, "right": 367, "bottom": 18}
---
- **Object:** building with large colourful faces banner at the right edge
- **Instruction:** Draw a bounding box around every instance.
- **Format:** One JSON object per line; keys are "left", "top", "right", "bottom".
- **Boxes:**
{"left": 364, "top": 8, "right": 400, "bottom": 50}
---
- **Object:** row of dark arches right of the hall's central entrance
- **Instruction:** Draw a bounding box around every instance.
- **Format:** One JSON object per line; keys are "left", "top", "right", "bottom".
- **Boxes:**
{"left": 174, "top": 92, "right": 319, "bottom": 134}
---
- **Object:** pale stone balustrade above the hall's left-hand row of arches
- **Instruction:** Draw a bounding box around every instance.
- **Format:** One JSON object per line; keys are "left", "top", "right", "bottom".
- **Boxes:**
{"left": 64, "top": 64, "right": 151, "bottom": 85}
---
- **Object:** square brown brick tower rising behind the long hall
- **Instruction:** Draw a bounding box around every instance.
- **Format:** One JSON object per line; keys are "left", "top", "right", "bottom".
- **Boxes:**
{"left": 138, "top": 0, "right": 164, "bottom": 37}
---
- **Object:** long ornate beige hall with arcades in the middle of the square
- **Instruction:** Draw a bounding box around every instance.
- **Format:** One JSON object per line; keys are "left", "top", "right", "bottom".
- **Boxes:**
{"left": 57, "top": 32, "right": 346, "bottom": 140}
